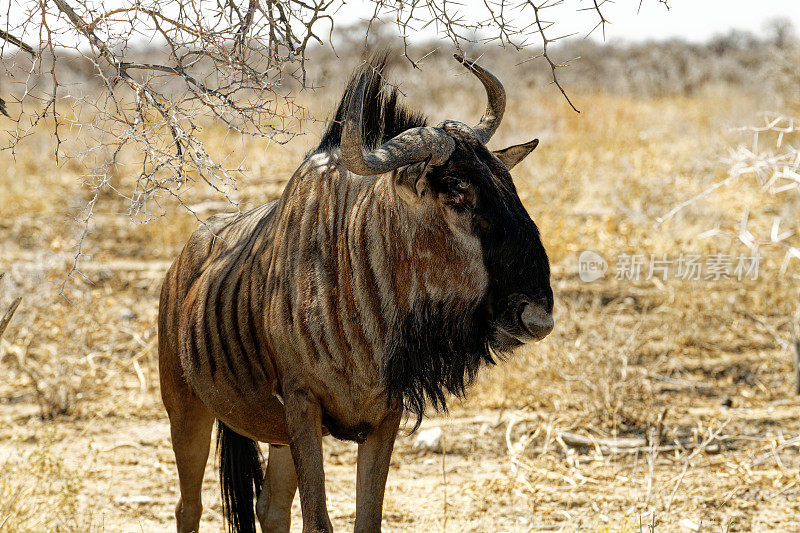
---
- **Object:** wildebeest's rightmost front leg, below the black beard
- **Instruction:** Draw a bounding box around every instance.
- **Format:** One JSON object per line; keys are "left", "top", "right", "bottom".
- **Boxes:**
{"left": 355, "top": 411, "right": 402, "bottom": 533}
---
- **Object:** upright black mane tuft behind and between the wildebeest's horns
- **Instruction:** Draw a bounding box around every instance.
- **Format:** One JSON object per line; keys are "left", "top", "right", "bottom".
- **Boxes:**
{"left": 314, "top": 52, "right": 427, "bottom": 153}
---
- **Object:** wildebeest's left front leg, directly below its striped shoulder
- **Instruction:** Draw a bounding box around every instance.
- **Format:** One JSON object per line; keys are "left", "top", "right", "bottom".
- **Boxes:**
{"left": 284, "top": 391, "right": 333, "bottom": 533}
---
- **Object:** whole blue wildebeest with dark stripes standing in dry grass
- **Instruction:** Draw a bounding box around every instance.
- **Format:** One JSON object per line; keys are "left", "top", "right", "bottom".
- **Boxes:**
{"left": 159, "top": 56, "right": 553, "bottom": 532}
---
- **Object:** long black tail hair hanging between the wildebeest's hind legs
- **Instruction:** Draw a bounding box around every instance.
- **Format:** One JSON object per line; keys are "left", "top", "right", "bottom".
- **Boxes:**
{"left": 217, "top": 421, "right": 264, "bottom": 533}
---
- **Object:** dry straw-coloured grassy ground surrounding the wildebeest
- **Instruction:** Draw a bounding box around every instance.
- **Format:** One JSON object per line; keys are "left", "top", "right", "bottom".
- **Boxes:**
{"left": 0, "top": 61, "right": 800, "bottom": 532}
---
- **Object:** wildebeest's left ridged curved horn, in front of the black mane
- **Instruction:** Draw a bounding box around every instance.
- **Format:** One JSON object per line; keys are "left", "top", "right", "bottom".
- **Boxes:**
{"left": 340, "top": 73, "right": 456, "bottom": 176}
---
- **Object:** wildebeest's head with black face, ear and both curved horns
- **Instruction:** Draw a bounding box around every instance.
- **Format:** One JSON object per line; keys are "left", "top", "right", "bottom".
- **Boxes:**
{"left": 341, "top": 56, "right": 553, "bottom": 351}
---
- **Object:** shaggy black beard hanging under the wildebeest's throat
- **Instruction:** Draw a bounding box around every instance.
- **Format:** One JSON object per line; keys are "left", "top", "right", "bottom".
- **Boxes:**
{"left": 383, "top": 303, "right": 495, "bottom": 430}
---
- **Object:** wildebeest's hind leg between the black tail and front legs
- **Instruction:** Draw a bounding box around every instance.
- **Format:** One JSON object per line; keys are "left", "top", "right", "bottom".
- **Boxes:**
{"left": 256, "top": 444, "right": 297, "bottom": 533}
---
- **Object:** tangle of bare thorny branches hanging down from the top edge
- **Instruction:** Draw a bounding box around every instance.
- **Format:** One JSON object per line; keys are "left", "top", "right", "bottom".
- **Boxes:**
{"left": 0, "top": 0, "right": 665, "bottom": 290}
